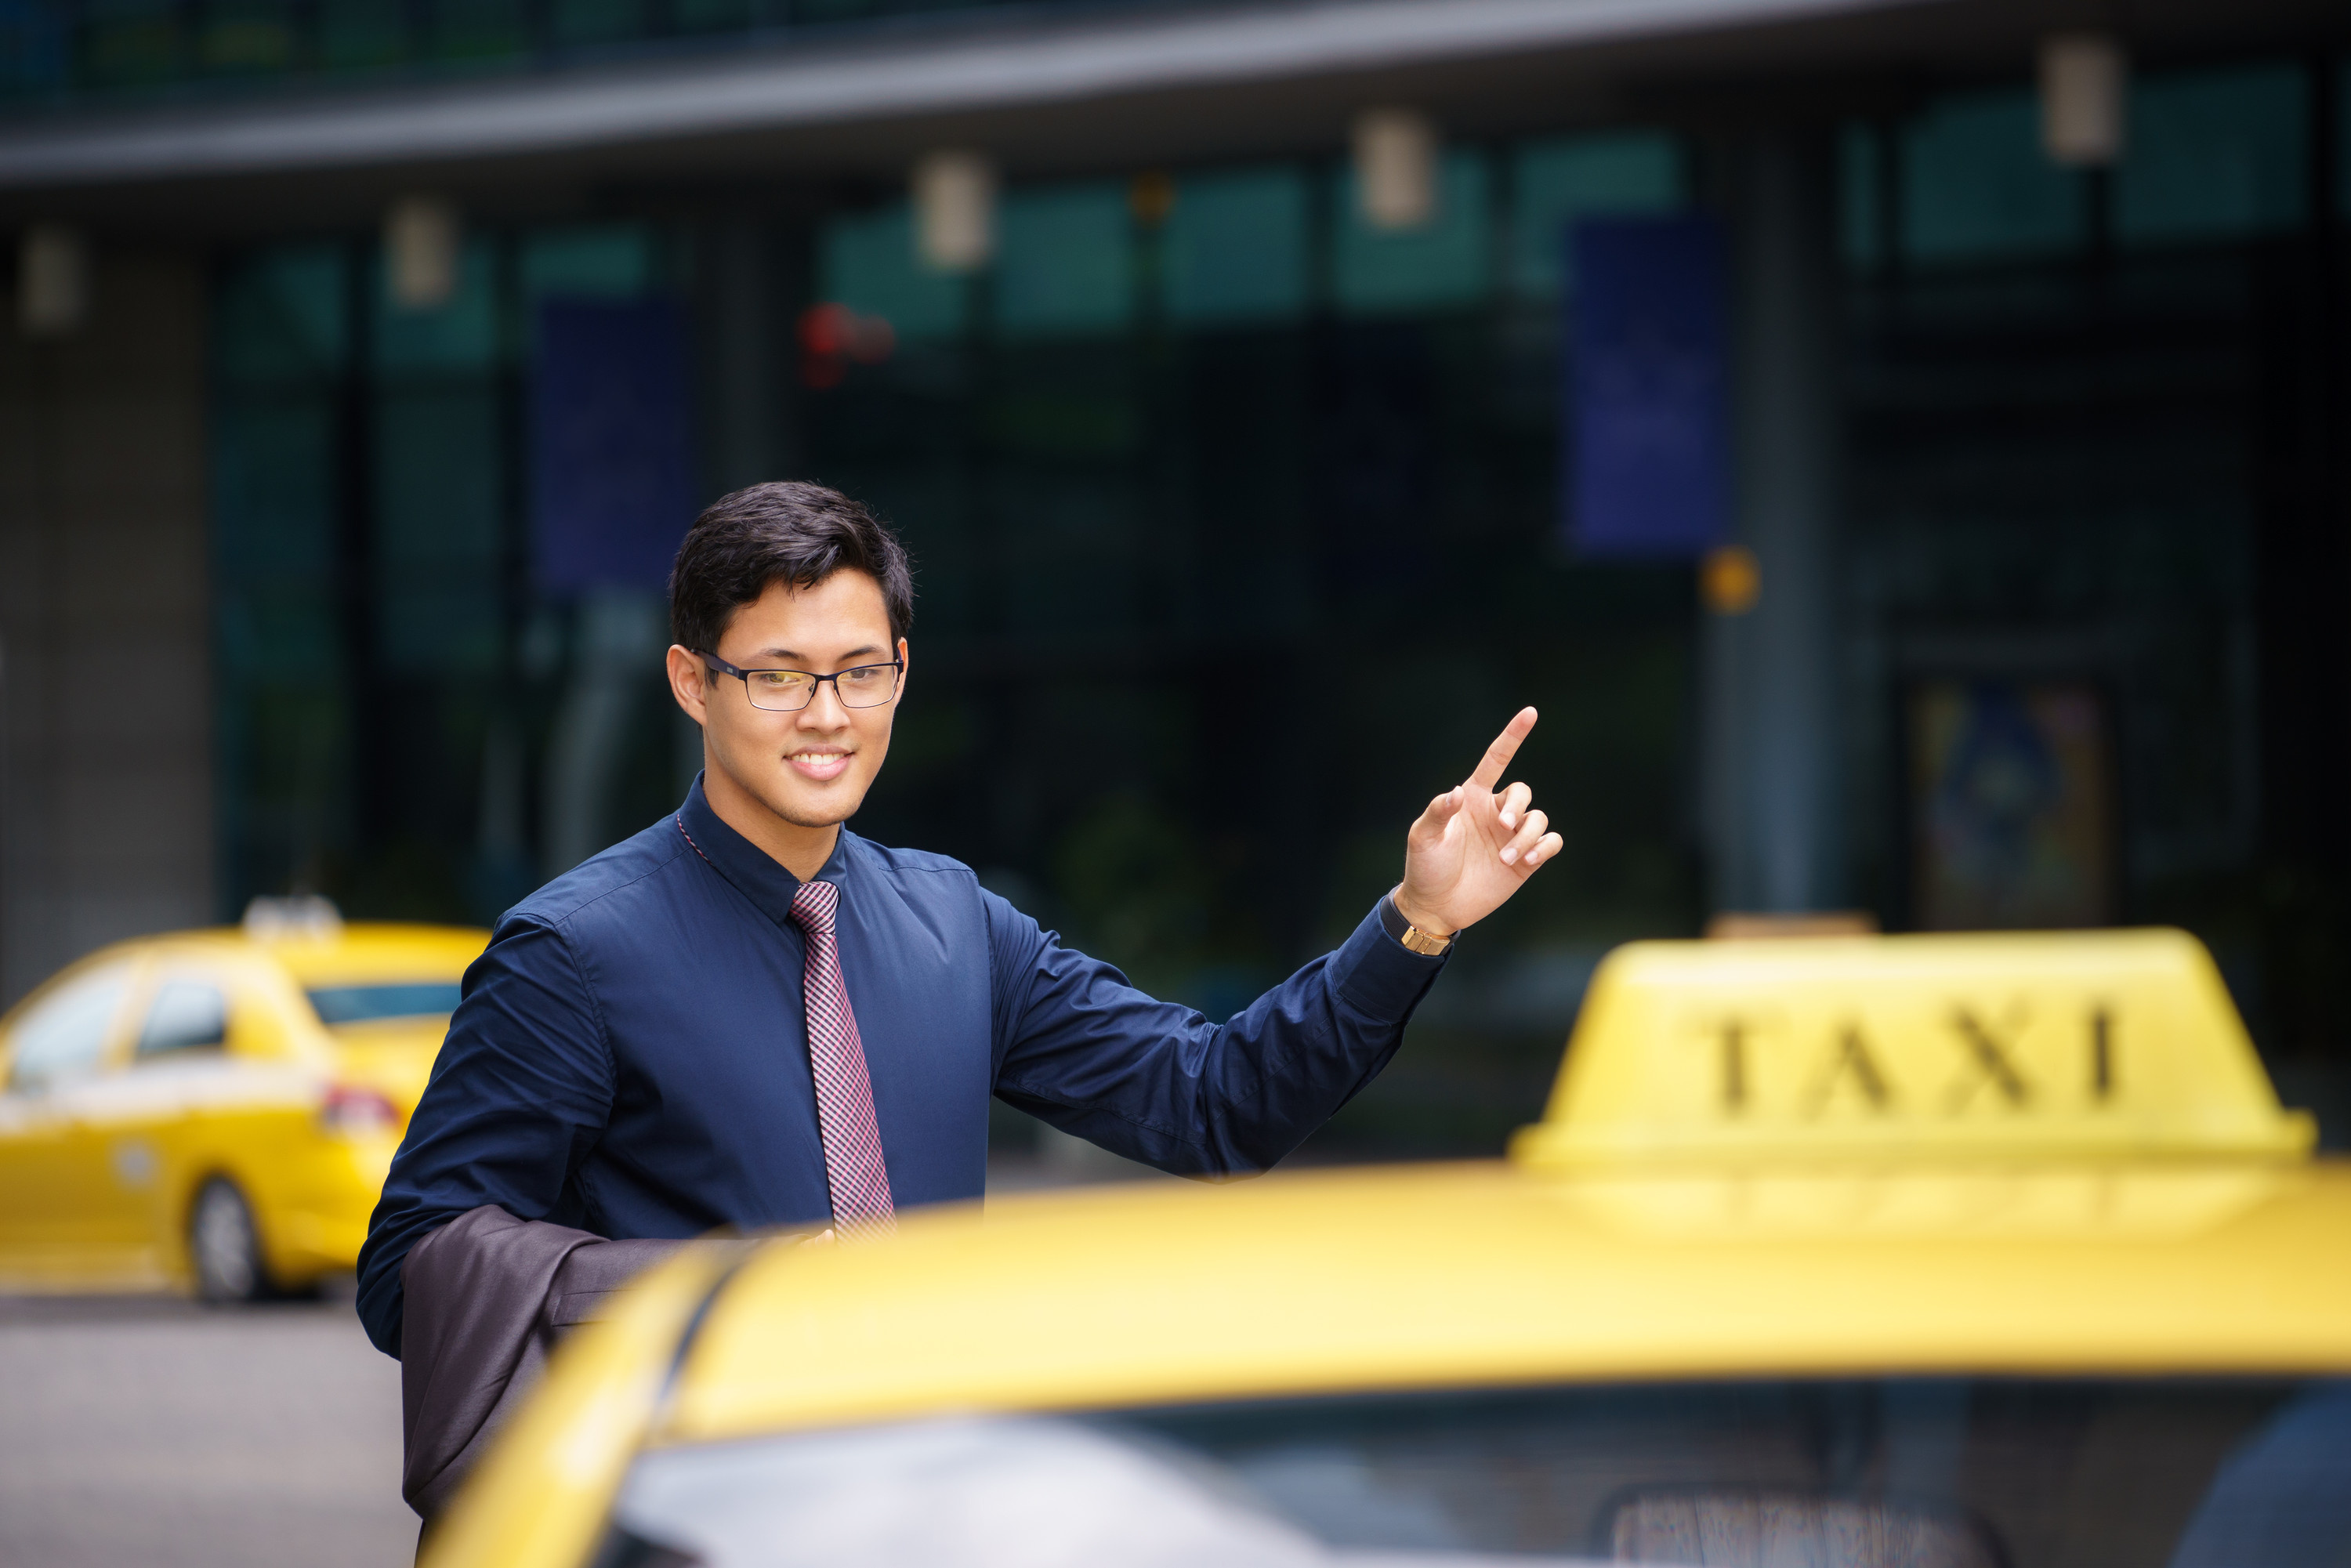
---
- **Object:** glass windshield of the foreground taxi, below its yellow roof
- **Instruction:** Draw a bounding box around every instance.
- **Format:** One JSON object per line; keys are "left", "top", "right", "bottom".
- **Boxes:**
{"left": 597, "top": 1378, "right": 2351, "bottom": 1568}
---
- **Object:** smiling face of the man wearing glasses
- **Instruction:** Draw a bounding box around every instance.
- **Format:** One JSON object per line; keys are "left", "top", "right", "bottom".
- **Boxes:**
{"left": 670, "top": 571, "right": 905, "bottom": 879}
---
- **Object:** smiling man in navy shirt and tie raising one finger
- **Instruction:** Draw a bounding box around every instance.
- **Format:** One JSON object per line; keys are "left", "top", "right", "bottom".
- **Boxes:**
{"left": 360, "top": 484, "right": 1559, "bottom": 1356}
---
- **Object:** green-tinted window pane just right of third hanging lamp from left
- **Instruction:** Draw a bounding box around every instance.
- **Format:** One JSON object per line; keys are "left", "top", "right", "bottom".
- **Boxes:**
{"left": 997, "top": 183, "right": 1136, "bottom": 336}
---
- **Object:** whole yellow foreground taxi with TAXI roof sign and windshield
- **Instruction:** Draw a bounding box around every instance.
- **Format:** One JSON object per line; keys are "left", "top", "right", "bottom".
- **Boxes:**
{"left": 423, "top": 931, "right": 2351, "bottom": 1568}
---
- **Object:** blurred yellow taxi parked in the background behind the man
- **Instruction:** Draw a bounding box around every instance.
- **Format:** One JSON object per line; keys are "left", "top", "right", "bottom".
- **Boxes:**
{"left": 0, "top": 900, "right": 489, "bottom": 1300}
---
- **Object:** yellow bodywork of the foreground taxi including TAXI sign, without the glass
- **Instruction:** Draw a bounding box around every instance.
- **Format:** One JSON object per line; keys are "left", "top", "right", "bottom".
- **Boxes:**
{"left": 426, "top": 933, "right": 2351, "bottom": 1568}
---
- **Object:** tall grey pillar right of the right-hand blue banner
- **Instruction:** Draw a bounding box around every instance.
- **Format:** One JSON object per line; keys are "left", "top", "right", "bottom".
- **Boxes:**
{"left": 1704, "top": 132, "right": 1846, "bottom": 912}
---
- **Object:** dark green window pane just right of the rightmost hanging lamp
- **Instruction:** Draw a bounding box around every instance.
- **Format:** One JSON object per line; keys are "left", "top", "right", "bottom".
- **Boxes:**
{"left": 2114, "top": 66, "right": 2309, "bottom": 242}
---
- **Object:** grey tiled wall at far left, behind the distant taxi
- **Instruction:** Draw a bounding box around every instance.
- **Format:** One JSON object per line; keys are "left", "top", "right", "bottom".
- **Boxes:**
{"left": 0, "top": 249, "right": 219, "bottom": 1006}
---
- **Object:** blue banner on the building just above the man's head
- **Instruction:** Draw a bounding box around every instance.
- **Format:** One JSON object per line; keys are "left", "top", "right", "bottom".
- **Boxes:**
{"left": 531, "top": 299, "right": 701, "bottom": 595}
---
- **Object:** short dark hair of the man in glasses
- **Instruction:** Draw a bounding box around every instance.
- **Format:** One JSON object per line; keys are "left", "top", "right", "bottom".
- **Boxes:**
{"left": 670, "top": 480, "right": 915, "bottom": 654}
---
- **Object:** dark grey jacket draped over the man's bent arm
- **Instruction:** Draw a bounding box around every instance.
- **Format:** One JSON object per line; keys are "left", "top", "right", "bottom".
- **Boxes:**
{"left": 400, "top": 1204, "right": 694, "bottom": 1523}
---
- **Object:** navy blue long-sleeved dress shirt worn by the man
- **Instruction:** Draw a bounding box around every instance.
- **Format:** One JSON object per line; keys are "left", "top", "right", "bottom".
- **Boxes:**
{"left": 360, "top": 780, "right": 1444, "bottom": 1356}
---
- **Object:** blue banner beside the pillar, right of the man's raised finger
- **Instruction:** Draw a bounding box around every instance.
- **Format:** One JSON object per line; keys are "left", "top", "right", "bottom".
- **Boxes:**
{"left": 1561, "top": 216, "right": 1730, "bottom": 559}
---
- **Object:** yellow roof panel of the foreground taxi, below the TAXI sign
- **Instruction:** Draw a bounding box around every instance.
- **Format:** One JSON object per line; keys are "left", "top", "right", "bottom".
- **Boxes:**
{"left": 658, "top": 1164, "right": 2351, "bottom": 1441}
